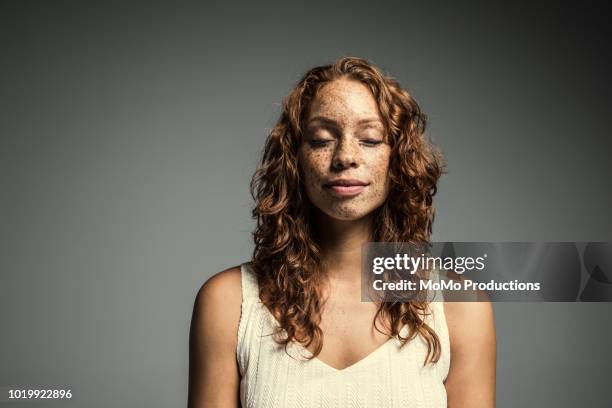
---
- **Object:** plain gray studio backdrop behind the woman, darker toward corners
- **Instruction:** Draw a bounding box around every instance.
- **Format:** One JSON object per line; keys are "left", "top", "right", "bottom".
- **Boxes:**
{"left": 0, "top": 1, "right": 612, "bottom": 408}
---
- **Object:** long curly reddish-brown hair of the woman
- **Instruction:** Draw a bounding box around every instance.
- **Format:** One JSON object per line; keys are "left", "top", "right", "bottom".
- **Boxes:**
{"left": 250, "top": 57, "right": 444, "bottom": 365}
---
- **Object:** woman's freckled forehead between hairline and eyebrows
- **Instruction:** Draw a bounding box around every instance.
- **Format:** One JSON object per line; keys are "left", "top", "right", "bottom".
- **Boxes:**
{"left": 308, "top": 78, "right": 380, "bottom": 124}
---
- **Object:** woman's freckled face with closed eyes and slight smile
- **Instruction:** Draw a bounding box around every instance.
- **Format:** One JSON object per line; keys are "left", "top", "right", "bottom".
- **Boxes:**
{"left": 298, "top": 78, "right": 391, "bottom": 220}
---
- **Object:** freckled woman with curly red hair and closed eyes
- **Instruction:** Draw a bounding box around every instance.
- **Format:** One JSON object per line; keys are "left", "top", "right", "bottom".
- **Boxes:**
{"left": 189, "top": 58, "right": 495, "bottom": 408}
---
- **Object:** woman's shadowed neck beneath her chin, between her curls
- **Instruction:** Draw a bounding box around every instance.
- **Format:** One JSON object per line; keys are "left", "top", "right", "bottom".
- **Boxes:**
{"left": 317, "top": 214, "right": 372, "bottom": 283}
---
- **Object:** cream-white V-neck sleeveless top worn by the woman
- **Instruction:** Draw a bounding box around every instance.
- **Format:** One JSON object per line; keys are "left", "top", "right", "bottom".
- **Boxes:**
{"left": 236, "top": 263, "right": 450, "bottom": 408}
